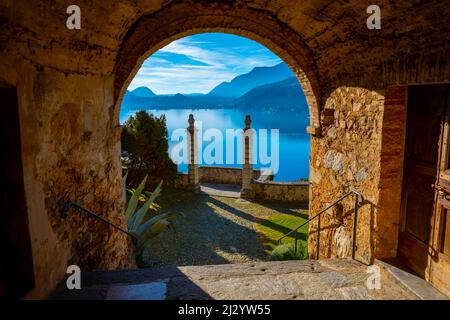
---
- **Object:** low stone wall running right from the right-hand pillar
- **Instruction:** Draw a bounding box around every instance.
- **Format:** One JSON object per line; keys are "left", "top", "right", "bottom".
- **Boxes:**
{"left": 252, "top": 180, "right": 309, "bottom": 202}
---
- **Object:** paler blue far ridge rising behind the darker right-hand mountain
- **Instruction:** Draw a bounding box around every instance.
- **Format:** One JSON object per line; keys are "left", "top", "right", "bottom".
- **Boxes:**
{"left": 208, "top": 62, "right": 294, "bottom": 98}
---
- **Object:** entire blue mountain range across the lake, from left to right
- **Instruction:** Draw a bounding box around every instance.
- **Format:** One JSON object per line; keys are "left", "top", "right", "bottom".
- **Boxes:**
{"left": 122, "top": 63, "right": 306, "bottom": 110}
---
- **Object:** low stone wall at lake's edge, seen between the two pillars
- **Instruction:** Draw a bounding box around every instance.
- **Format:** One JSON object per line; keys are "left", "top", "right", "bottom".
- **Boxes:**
{"left": 199, "top": 166, "right": 261, "bottom": 185}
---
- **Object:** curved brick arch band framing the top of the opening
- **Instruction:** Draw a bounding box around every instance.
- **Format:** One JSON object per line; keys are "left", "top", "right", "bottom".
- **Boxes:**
{"left": 114, "top": 3, "right": 321, "bottom": 133}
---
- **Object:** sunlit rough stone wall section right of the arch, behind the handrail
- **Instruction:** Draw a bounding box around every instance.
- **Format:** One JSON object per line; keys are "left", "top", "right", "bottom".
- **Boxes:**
{"left": 309, "top": 87, "right": 384, "bottom": 261}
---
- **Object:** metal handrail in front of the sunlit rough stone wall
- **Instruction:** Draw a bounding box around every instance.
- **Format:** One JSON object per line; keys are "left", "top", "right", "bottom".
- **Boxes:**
{"left": 278, "top": 189, "right": 364, "bottom": 259}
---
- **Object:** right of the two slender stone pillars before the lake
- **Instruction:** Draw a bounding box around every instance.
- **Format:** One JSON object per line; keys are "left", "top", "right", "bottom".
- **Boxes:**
{"left": 241, "top": 115, "right": 253, "bottom": 198}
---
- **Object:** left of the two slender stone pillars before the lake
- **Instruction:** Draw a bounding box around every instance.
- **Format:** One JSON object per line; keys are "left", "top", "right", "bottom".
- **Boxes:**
{"left": 186, "top": 114, "right": 200, "bottom": 192}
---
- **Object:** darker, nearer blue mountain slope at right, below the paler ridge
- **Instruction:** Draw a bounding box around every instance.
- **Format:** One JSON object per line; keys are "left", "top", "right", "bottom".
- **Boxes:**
{"left": 233, "top": 77, "right": 307, "bottom": 110}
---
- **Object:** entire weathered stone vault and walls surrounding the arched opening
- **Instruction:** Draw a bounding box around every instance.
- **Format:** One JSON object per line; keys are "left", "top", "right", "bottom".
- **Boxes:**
{"left": 0, "top": 0, "right": 450, "bottom": 298}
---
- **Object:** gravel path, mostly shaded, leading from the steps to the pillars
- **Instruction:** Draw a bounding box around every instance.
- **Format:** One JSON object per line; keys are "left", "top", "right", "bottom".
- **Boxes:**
{"left": 143, "top": 195, "right": 308, "bottom": 267}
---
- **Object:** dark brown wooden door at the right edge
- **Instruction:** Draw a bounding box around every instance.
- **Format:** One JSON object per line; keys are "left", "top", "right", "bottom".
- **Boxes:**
{"left": 398, "top": 85, "right": 450, "bottom": 296}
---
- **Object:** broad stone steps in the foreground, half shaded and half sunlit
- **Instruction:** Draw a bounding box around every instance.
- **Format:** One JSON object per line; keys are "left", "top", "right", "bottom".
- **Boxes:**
{"left": 51, "top": 258, "right": 445, "bottom": 300}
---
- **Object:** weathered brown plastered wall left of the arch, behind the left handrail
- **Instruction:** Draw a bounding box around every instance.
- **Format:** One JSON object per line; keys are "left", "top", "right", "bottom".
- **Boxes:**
{"left": 0, "top": 63, "right": 133, "bottom": 298}
